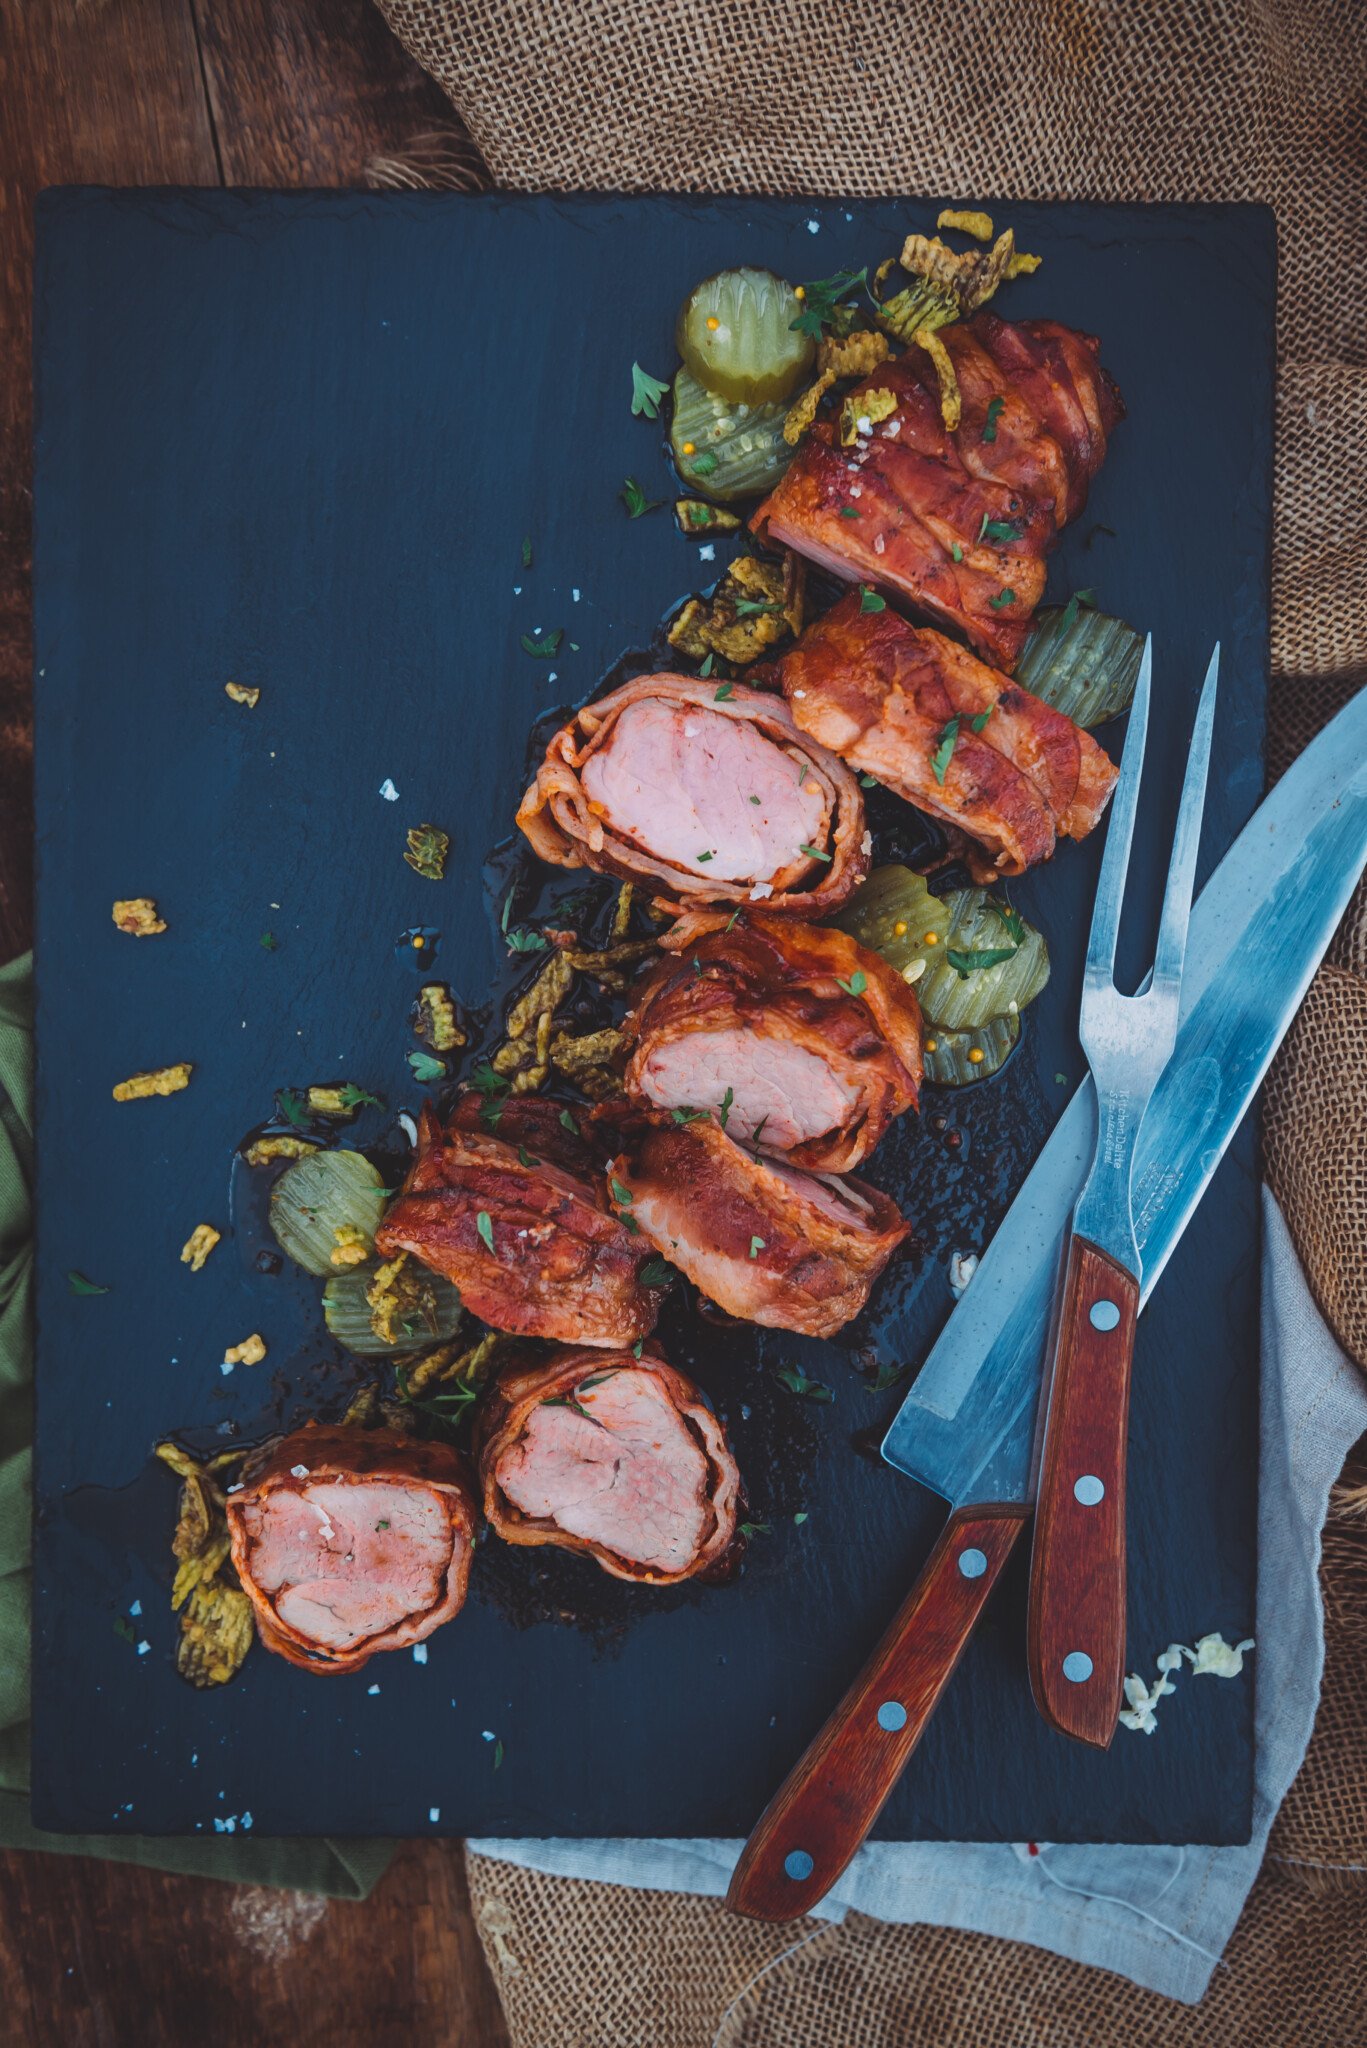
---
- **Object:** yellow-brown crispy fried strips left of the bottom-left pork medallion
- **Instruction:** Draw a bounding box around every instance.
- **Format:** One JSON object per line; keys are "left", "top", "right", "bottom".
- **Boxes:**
{"left": 156, "top": 1444, "right": 256, "bottom": 1686}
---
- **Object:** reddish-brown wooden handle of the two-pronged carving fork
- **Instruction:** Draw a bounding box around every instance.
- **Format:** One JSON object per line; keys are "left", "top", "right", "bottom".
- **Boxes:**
{"left": 1027, "top": 1237, "right": 1140, "bottom": 1749}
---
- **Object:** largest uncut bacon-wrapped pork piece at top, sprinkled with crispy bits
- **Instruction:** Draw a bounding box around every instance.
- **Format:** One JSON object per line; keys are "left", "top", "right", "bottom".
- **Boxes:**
{"left": 752, "top": 313, "right": 1123, "bottom": 670}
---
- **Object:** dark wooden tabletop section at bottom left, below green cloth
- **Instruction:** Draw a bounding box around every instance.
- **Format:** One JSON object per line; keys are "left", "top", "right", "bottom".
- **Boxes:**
{"left": 0, "top": 1841, "right": 508, "bottom": 2048}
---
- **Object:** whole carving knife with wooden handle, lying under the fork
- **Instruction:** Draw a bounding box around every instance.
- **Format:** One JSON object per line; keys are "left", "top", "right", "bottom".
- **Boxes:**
{"left": 726, "top": 690, "right": 1367, "bottom": 1921}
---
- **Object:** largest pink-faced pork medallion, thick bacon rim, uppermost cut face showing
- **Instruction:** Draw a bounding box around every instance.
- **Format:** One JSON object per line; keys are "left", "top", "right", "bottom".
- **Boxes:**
{"left": 516, "top": 676, "right": 869, "bottom": 918}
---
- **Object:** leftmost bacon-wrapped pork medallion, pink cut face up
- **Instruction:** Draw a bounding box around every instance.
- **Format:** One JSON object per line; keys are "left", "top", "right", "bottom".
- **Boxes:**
{"left": 227, "top": 1423, "right": 480, "bottom": 1673}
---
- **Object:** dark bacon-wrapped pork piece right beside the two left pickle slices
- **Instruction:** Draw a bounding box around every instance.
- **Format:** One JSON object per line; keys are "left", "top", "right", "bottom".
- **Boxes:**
{"left": 375, "top": 1094, "right": 664, "bottom": 1346}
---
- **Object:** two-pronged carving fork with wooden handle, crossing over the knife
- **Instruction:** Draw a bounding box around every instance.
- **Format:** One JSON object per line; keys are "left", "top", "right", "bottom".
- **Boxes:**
{"left": 1027, "top": 643, "right": 1219, "bottom": 1749}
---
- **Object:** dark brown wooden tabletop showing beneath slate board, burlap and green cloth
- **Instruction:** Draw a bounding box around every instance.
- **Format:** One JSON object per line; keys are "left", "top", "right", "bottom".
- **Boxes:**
{"left": 0, "top": 0, "right": 508, "bottom": 2048}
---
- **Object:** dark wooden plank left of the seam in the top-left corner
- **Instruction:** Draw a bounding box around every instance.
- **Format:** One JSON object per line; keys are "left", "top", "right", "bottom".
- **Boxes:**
{"left": 0, "top": 0, "right": 217, "bottom": 961}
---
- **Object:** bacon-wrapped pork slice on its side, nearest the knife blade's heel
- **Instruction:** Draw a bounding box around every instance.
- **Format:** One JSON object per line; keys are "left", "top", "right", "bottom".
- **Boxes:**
{"left": 609, "top": 1118, "right": 910, "bottom": 1337}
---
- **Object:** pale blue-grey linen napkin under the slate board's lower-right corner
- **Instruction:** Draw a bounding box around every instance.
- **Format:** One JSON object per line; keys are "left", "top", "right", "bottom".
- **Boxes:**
{"left": 469, "top": 1190, "right": 1367, "bottom": 2005}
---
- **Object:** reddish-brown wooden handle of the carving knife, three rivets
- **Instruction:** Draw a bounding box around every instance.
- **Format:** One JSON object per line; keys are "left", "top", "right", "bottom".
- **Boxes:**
{"left": 726, "top": 1501, "right": 1029, "bottom": 1921}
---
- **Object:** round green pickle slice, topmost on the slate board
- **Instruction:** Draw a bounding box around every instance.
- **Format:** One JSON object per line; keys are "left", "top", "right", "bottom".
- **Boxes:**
{"left": 674, "top": 270, "right": 816, "bottom": 406}
